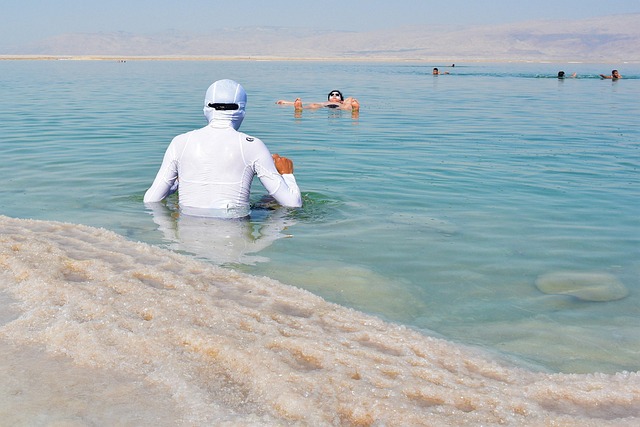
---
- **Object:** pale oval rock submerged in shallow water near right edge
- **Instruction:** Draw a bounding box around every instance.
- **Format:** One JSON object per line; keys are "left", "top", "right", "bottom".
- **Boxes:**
{"left": 536, "top": 271, "right": 629, "bottom": 302}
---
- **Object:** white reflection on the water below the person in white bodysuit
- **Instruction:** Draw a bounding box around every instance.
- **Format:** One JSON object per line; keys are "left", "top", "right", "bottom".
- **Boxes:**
{"left": 147, "top": 201, "right": 295, "bottom": 265}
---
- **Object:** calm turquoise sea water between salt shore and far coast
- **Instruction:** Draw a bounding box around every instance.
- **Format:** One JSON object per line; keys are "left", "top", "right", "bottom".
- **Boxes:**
{"left": 0, "top": 61, "right": 640, "bottom": 372}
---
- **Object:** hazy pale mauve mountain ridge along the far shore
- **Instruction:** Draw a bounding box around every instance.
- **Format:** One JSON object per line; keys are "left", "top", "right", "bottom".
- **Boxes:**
{"left": 6, "top": 13, "right": 640, "bottom": 62}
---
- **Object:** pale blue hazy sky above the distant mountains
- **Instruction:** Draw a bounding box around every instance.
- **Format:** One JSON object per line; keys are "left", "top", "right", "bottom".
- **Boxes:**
{"left": 0, "top": 0, "right": 640, "bottom": 47}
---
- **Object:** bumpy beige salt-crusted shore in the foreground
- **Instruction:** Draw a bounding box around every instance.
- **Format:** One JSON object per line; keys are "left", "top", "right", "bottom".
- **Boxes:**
{"left": 0, "top": 216, "right": 640, "bottom": 427}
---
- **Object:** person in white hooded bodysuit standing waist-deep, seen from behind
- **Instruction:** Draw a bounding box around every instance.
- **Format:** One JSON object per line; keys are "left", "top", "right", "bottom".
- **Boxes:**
{"left": 144, "top": 80, "right": 302, "bottom": 218}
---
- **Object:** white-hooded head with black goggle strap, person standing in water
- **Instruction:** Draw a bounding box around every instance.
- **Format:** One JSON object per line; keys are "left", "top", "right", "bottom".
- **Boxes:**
{"left": 203, "top": 79, "right": 247, "bottom": 130}
